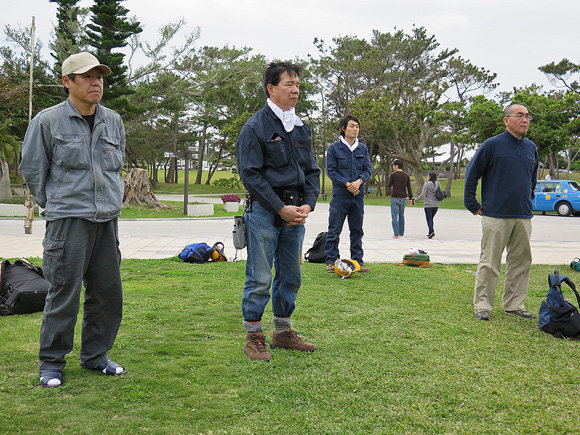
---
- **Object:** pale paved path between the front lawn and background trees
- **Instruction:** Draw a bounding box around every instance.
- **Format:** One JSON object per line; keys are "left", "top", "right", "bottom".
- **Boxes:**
{"left": 0, "top": 195, "right": 580, "bottom": 265}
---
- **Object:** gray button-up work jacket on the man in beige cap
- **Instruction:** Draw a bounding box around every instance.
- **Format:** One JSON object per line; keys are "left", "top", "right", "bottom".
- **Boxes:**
{"left": 19, "top": 99, "right": 125, "bottom": 222}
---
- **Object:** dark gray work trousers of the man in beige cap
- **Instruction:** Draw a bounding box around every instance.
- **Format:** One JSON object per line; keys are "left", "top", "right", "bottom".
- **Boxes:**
{"left": 38, "top": 218, "right": 123, "bottom": 370}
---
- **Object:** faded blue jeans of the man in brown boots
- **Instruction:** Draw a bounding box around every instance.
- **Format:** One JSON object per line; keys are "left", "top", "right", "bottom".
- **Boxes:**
{"left": 242, "top": 201, "right": 304, "bottom": 322}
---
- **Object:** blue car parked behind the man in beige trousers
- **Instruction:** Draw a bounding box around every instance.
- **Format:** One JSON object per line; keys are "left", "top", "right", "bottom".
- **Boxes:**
{"left": 534, "top": 180, "right": 580, "bottom": 216}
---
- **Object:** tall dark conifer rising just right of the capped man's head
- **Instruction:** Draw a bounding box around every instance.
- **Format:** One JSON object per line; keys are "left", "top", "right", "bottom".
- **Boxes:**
{"left": 86, "top": 0, "right": 143, "bottom": 116}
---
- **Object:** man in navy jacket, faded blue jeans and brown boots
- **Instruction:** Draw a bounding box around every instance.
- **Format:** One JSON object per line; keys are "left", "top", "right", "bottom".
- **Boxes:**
{"left": 236, "top": 62, "right": 320, "bottom": 361}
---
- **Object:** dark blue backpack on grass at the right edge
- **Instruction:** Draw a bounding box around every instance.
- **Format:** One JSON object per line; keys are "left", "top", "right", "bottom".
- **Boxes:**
{"left": 539, "top": 270, "right": 580, "bottom": 338}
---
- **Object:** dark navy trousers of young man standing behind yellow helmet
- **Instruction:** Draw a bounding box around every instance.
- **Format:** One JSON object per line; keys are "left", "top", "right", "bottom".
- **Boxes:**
{"left": 324, "top": 194, "right": 364, "bottom": 266}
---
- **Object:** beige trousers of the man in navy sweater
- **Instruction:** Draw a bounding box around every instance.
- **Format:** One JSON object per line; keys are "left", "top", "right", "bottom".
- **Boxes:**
{"left": 473, "top": 216, "right": 532, "bottom": 312}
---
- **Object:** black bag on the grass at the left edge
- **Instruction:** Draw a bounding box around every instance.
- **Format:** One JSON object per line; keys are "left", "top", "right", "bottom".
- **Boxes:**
{"left": 0, "top": 259, "right": 50, "bottom": 316}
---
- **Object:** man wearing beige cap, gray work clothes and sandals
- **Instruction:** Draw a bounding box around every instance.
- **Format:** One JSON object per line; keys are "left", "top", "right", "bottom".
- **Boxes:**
{"left": 19, "top": 53, "right": 126, "bottom": 387}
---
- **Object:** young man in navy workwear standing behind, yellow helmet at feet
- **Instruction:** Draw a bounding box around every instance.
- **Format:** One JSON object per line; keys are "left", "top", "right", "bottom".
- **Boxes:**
{"left": 324, "top": 115, "right": 372, "bottom": 273}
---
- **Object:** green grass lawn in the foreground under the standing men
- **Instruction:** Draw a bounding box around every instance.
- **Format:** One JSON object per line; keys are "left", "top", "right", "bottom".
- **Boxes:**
{"left": 0, "top": 259, "right": 580, "bottom": 435}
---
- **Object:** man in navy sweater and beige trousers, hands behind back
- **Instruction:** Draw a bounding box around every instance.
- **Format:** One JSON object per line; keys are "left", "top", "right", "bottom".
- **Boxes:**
{"left": 464, "top": 104, "right": 538, "bottom": 320}
